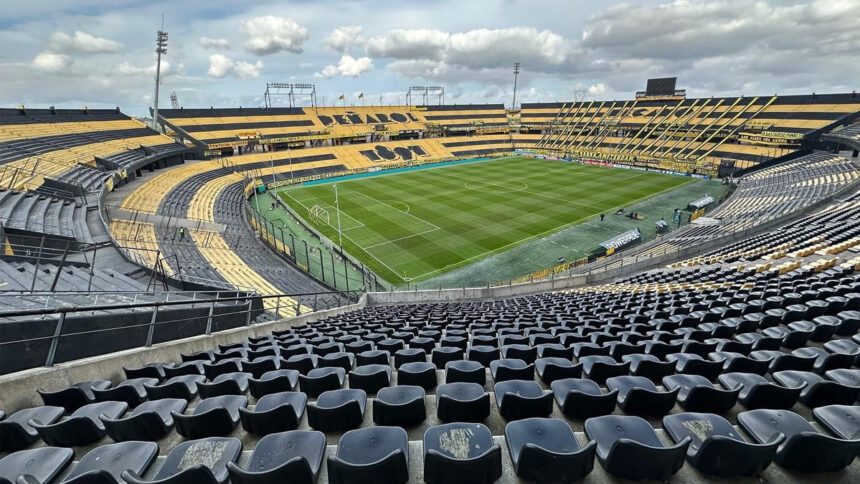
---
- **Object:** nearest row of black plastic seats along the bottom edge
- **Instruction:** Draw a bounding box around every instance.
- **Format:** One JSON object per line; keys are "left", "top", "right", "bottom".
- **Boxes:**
{"left": 6, "top": 405, "right": 860, "bottom": 484}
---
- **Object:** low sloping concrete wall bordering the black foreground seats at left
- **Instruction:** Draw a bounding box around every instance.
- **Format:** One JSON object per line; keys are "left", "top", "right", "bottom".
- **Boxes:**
{"left": 0, "top": 298, "right": 366, "bottom": 414}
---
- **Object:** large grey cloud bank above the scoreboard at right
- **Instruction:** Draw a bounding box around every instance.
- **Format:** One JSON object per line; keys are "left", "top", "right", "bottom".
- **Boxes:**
{"left": 581, "top": 0, "right": 860, "bottom": 95}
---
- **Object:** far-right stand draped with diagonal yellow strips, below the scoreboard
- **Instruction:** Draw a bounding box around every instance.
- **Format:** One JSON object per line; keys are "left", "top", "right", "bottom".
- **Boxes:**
{"left": 521, "top": 94, "right": 860, "bottom": 173}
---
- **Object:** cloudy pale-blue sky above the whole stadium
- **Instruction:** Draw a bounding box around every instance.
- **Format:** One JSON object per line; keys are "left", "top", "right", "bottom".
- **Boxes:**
{"left": 0, "top": 0, "right": 860, "bottom": 115}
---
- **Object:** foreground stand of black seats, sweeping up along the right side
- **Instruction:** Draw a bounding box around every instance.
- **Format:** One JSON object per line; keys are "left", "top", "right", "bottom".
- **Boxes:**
{"left": 0, "top": 186, "right": 860, "bottom": 482}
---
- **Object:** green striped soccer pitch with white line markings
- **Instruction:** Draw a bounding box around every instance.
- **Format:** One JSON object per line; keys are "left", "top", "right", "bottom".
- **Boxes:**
{"left": 278, "top": 158, "right": 691, "bottom": 284}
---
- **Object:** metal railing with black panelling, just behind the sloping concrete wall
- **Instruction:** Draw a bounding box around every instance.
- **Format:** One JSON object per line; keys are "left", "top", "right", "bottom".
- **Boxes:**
{"left": 0, "top": 291, "right": 364, "bottom": 374}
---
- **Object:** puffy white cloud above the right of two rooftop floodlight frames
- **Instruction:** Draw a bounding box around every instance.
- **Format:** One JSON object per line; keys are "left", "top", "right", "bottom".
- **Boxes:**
{"left": 367, "top": 29, "right": 450, "bottom": 60}
